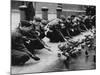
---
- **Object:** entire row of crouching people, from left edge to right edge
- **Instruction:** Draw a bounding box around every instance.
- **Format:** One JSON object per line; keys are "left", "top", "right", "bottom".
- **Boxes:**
{"left": 11, "top": 4, "right": 96, "bottom": 65}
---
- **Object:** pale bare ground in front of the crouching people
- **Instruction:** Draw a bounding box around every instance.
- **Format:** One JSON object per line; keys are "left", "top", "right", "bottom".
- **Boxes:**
{"left": 11, "top": 32, "right": 95, "bottom": 74}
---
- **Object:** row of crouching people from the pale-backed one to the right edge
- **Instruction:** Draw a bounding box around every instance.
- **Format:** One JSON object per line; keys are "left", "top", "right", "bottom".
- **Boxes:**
{"left": 46, "top": 15, "right": 95, "bottom": 42}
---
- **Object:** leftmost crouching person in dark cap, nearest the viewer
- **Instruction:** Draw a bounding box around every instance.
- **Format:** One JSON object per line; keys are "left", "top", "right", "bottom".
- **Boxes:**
{"left": 11, "top": 21, "right": 40, "bottom": 65}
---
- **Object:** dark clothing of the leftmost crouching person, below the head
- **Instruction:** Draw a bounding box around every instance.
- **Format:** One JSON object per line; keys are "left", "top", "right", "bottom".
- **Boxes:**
{"left": 11, "top": 28, "right": 30, "bottom": 65}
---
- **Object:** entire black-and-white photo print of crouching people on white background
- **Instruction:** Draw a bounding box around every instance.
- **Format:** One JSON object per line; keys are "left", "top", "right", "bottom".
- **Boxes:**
{"left": 10, "top": 0, "right": 96, "bottom": 75}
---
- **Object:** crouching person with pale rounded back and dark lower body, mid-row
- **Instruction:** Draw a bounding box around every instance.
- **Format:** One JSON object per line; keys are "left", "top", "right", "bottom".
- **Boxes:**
{"left": 46, "top": 18, "right": 64, "bottom": 42}
